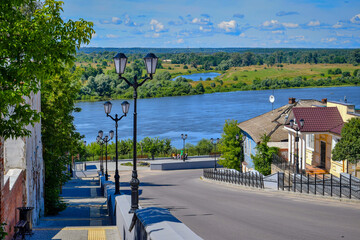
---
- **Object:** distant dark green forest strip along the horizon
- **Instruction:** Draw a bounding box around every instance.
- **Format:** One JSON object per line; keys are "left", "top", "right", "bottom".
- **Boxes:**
{"left": 77, "top": 48, "right": 360, "bottom": 66}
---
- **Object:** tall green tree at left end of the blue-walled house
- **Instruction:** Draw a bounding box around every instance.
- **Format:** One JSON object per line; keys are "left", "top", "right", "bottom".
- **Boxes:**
{"left": 219, "top": 120, "right": 244, "bottom": 170}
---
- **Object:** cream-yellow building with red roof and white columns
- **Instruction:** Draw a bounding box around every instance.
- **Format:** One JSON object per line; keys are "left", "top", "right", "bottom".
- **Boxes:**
{"left": 284, "top": 101, "right": 360, "bottom": 176}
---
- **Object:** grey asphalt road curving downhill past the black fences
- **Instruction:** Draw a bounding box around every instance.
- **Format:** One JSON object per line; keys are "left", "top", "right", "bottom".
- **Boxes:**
{"left": 125, "top": 170, "right": 360, "bottom": 240}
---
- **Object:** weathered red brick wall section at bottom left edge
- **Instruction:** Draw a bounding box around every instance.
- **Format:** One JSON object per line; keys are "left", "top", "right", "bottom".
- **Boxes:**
{"left": 1, "top": 171, "right": 25, "bottom": 240}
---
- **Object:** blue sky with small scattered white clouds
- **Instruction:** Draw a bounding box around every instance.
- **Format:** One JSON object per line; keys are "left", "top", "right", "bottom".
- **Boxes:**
{"left": 62, "top": 0, "right": 360, "bottom": 48}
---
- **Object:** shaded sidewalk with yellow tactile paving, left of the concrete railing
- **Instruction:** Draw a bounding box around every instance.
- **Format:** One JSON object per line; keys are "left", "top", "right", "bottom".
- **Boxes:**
{"left": 26, "top": 166, "right": 120, "bottom": 240}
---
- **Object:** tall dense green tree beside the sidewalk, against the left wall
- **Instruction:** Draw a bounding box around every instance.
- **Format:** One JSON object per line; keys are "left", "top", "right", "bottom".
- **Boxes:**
{"left": 41, "top": 68, "right": 84, "bottom": 215}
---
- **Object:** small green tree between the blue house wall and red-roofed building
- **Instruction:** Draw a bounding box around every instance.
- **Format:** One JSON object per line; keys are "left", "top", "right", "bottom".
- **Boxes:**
{"left": 251, "top": 134, "right": 279, "bottom": 175}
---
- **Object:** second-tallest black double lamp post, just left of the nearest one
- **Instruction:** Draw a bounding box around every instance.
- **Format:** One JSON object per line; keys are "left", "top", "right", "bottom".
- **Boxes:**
{"left": 104, "top": 101, "right": 130, "bottom": 194}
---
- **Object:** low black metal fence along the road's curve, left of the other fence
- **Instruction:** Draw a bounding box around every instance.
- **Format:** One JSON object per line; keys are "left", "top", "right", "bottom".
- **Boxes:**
{"left": 203, "top": 169, "right": 264, "bottom": 188}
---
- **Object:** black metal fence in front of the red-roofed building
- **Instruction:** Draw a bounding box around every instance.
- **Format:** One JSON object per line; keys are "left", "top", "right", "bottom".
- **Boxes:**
{"left": 278, "top": 172, "right": 360, "bottom": 199}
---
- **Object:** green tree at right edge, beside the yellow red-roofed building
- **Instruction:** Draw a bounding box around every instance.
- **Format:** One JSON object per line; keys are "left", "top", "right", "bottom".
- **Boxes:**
{"left": 332, "top": 118, "right": 360, "bottom": 163}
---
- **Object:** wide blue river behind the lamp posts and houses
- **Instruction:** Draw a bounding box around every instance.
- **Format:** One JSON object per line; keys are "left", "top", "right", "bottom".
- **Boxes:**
{"left": 74, "top": 87, "right": 360, "bottom": 148}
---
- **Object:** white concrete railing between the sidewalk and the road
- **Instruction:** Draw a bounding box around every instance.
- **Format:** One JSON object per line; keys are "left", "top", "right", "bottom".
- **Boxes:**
{"left": 100, "top": 173, "right": 202, "bottom": 240}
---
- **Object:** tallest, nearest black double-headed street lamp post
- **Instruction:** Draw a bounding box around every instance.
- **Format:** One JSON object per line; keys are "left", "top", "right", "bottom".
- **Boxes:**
{"left": 114, "top": 53, "right": 158, "bottom": 213}
